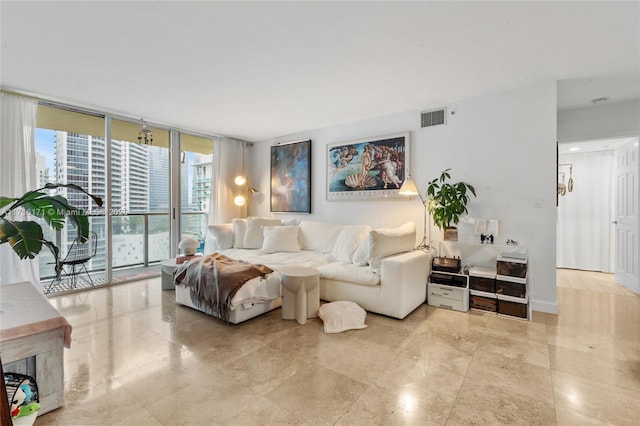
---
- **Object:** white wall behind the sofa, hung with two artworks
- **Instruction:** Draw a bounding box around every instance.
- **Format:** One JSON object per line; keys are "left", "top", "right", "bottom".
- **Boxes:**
{"left": 249, "top": 82, "right": 557, "bottom": 313}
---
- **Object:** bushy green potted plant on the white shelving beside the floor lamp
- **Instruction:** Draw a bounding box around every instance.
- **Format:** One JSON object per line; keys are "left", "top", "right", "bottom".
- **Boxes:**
{"left": 427, "top": 169, "right": 476, "bottom": 241}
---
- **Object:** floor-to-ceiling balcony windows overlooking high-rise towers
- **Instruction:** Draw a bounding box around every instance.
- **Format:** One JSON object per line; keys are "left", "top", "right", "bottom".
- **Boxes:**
{"left": 36, "top": 104, "right": 218, "bottom": 285}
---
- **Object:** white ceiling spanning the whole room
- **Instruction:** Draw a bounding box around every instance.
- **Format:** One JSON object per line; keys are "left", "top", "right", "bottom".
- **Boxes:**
{"left": 0, "top": 0, "right": 640, "bottom": 140}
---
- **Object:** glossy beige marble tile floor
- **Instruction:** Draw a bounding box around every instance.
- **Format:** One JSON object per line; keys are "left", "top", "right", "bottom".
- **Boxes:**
{"left": 36, "top": 270, "right": 640, "bottom": 426}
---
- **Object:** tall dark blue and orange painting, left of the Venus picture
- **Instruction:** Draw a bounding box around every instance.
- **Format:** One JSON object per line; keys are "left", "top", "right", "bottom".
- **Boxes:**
{"left": 271, "top": 139, "right": 311, "bottom": 213}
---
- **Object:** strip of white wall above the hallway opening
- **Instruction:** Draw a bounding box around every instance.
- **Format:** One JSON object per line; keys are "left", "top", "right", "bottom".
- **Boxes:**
{"left": 558, "top": 100, "right": 640, "bottom": 142}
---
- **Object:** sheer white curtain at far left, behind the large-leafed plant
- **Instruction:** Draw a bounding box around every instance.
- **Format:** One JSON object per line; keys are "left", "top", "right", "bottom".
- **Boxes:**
{"left": 0, "top": 92, "right": 40, "bottom": 285}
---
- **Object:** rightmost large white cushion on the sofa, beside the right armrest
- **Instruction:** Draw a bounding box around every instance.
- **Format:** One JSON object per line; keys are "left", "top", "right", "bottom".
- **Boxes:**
{"left": 367, "top": 222, "right": 416, "bottom": 273}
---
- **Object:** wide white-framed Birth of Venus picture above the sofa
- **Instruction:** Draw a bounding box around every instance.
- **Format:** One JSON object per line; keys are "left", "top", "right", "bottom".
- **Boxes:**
{"left": 327, "top": 132, "right": 410, "bottom": 201}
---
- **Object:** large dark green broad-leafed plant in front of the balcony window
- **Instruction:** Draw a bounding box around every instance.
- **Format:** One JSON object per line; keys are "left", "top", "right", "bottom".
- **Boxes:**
{"left": 0, "top": 183, "right": 102, "bottom": 277}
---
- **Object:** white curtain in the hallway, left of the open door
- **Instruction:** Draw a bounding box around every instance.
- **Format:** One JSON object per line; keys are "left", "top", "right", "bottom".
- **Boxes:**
{"left": 557, "top": 151, "right": 615, "bottom": 272}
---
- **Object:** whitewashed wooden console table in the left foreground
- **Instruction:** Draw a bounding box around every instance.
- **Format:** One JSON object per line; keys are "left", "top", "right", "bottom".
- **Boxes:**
{"left": 0, "top": 282, "right": 71, "bottom": 415}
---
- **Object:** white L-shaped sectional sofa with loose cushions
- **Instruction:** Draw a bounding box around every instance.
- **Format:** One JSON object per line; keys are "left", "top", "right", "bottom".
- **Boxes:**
{"left": 176, "top": 217, "right": 431, "bottom": 322}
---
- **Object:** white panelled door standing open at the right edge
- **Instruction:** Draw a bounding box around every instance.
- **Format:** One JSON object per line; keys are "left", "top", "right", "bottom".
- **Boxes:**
{"left": 614, "top": 139, "right": 640, "bottom": 293}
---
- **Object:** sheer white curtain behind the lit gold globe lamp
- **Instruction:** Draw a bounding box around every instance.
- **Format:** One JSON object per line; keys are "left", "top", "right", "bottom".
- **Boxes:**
{"left": 209, "top": 138, "right": 246, "bottom": 225}
